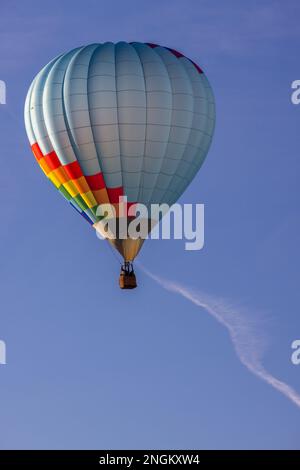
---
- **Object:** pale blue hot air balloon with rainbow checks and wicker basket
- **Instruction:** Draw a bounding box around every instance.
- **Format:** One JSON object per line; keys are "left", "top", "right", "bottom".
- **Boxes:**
{"left": 25, "top": 42, "right": 215, "bottom": 288}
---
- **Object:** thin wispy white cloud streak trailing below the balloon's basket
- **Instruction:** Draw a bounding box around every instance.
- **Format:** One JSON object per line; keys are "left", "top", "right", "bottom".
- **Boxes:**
{"left": 142, "top": 267, "right": 300, "bottom": 408}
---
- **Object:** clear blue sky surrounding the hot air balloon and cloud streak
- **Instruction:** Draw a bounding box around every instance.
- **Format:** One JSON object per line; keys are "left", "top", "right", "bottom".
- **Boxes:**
{"left": 0, "top": 0, "right": 300, "bottom": 449}
